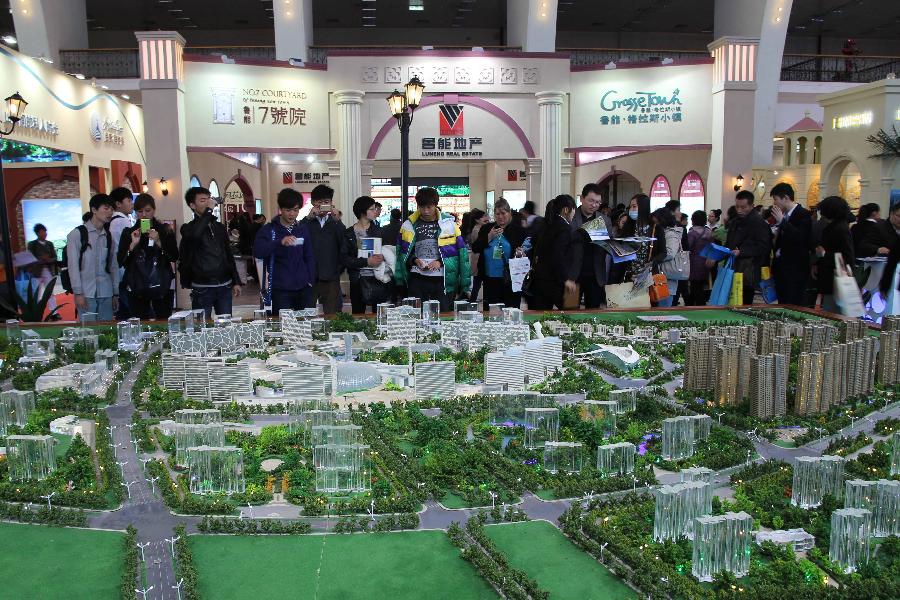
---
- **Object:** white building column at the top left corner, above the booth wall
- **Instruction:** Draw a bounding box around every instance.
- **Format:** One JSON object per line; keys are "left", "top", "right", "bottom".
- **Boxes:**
{"left": 9, "top": 0, "right": 88, "bottom": 65}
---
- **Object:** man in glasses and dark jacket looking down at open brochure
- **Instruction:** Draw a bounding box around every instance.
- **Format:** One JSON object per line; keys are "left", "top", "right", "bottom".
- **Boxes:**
{"left": 569, "top": 183, "right": 612, "bottom": 308}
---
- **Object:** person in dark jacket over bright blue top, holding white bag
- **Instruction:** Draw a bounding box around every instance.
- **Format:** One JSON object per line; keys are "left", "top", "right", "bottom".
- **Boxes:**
{"left": 472, "top": 198, "right": 525, "bottom": 310}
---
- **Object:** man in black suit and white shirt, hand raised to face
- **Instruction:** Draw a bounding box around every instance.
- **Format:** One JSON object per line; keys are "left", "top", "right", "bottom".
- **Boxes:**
{"left": 769, "top": 183, "right": 812, "bottom": 306}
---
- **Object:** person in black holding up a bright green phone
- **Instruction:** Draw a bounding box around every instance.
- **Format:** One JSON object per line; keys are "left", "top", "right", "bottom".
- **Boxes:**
{"left": 117, "top": 194, "right": 178, "bottom": 319}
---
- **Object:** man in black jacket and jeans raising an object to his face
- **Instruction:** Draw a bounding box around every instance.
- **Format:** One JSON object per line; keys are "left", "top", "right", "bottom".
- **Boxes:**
{"left": 178, "top": 187, "right": 241, "bottom": 319}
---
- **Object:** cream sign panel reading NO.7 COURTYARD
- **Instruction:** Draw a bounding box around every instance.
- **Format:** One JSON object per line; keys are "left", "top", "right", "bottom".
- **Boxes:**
{"left": 184, "top": 60, "right": 329, "bottom": 149}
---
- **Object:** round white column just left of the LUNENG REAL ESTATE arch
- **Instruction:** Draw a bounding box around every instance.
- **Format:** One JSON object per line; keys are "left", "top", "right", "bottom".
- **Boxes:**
{"left": 334, "top": 90, "right": 371, "bottom": 220}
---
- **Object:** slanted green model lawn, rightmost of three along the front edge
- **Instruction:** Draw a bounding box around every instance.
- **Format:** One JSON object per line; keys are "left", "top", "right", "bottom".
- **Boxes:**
{"left": 485, "top": 521, "right": 637, "bottom": 600}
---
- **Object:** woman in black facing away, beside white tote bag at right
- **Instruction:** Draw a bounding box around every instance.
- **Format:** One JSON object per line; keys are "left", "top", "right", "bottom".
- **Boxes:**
{"left": 816, "top": 196, "right": 855, "bottom": 313}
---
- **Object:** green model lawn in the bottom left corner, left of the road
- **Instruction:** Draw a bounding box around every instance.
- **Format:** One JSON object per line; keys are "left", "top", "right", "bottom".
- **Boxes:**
{"left": 0, "top": 523, "right": 124, "bottom": 600}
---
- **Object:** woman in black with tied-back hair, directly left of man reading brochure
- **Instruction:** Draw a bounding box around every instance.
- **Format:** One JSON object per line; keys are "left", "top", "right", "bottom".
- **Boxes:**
{"left": 528, "top": 194, "right": 577, "bottom": 310}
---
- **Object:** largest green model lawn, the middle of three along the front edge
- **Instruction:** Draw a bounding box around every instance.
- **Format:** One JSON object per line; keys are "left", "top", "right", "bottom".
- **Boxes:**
{"left": 190, "top": 531, "right": 496, "bottom": 600}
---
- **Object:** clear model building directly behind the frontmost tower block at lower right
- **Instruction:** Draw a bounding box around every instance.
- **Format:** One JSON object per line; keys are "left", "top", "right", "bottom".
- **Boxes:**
{"left": 653, "top": 481, "right": 712, "bottom": 542}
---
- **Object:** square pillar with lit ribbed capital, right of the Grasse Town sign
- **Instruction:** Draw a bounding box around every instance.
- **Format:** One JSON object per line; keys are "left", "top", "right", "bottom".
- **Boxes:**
{"left": 706, "top": 37, "right": 758, "bottom": 209}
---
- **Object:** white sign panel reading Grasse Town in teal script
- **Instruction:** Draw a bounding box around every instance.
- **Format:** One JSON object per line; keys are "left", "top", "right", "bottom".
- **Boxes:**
{"left": 571, "top": 64, "right": 712, "bottom": 148}
